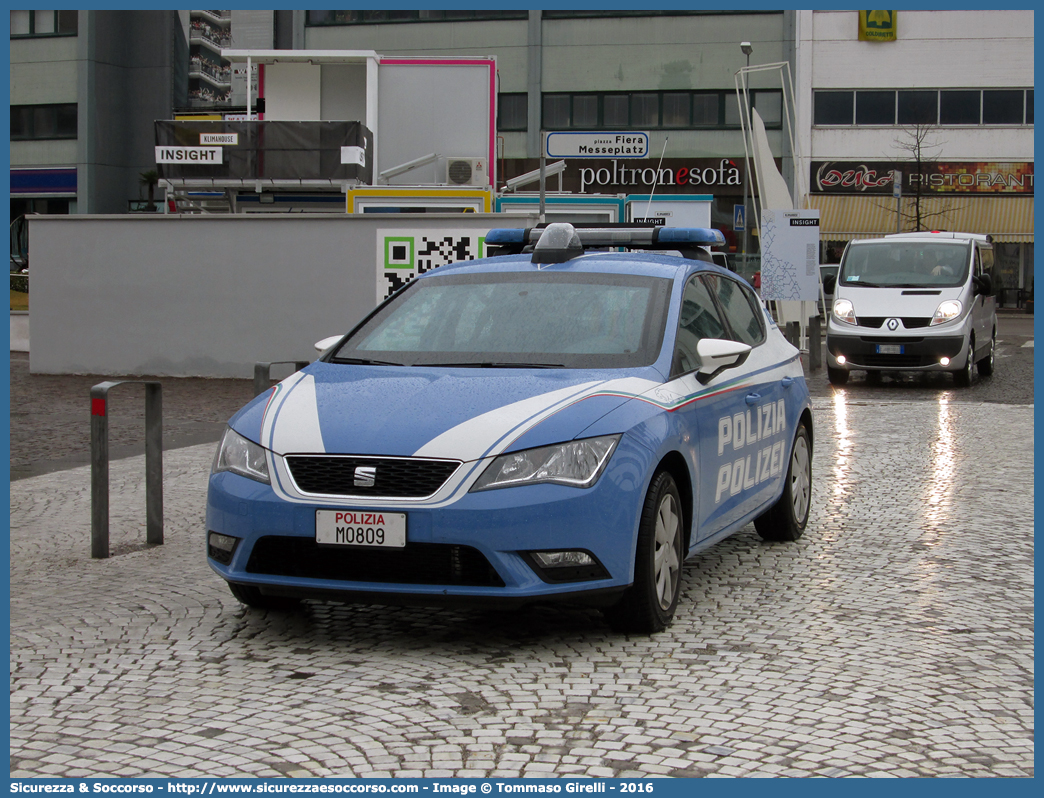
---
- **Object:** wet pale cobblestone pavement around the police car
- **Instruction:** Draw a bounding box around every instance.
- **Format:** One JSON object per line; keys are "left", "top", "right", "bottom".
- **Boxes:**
{"left": 10, "top": 399, "right": 1034, "bottom": 777}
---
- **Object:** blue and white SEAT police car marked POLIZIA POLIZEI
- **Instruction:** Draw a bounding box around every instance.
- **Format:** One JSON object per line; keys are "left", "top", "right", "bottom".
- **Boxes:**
{"left": 207, "top": 224, "right": 812, "bottom": 633}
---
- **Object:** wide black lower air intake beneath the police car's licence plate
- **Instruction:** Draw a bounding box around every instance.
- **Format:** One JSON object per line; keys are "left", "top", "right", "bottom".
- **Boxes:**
{"left": 246, "top": 536, "right": 504, "bottom": 587}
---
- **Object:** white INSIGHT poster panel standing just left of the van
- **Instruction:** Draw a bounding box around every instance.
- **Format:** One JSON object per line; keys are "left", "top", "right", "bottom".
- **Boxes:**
{"left": 760, "top": 209, "right": 820, "bottom": 302}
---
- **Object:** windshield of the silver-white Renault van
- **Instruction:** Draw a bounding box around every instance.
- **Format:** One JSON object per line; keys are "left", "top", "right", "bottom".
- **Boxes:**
{"left": 837, "top": 240, "right": 970, "bottom": 288}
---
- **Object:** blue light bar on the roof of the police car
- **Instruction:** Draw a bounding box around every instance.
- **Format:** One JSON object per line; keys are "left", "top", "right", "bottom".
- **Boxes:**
{"left": 485, "top": 221, "right": 726, "bottom": 262}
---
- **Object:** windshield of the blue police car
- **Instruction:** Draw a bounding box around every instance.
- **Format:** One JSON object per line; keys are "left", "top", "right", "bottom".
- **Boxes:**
{"left": 330, "top": 272, "right": 671, "bottom": 369}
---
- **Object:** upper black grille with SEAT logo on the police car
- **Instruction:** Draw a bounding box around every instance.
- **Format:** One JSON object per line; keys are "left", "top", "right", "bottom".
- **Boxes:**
{"left": 286, "top": 454, "right": 460, "bottom": 498}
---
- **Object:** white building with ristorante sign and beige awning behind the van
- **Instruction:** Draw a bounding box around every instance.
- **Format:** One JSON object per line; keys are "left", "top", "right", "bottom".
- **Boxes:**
{"left": 796, "top": 10, "right": 1034, "bottom": 305}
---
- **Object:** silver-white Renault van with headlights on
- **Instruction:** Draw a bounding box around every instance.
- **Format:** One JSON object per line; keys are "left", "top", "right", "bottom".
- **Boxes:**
{"left": 825, "top": 233, "right": 997, "bottom": 386}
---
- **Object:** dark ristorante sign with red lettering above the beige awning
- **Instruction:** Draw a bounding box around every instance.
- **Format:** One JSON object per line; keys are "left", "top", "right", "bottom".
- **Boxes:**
{"left": 811, "top": 161, "right": 1034, "bottom": 196}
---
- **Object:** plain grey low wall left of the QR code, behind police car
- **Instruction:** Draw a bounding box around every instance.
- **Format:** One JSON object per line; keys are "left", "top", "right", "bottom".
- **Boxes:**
{"left": 27, "top": 213, "right": 536, "bottom": 378}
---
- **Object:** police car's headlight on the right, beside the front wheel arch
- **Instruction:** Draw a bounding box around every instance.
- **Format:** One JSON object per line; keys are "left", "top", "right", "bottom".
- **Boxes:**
{"left": 472, "top": 435, "right": 620, "bottom": 491}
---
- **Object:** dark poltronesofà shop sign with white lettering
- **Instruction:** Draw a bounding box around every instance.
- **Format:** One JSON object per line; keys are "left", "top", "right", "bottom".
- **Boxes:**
{"left": 501, "top": 158, "right": 743, "bottom": 196}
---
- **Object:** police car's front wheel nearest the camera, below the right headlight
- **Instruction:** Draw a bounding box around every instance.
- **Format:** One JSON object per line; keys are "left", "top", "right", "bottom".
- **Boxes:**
{"left": 602, "top": 471, "right": 685, "bottom": 634}
